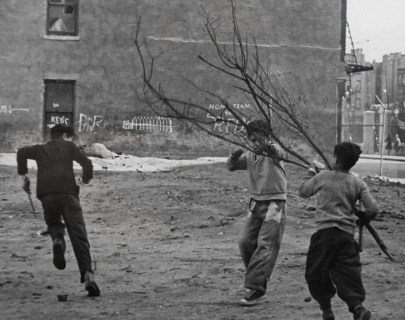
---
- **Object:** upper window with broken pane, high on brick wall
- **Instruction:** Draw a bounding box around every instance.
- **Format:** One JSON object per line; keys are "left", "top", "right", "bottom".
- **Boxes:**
{"left": 46, "top": 0, "right": 79, "bottom": 36}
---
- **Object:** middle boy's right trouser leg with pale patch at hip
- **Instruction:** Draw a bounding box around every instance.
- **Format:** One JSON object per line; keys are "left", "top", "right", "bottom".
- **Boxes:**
{"left": 245, "top": 201, "right": 286, "bottom": 292}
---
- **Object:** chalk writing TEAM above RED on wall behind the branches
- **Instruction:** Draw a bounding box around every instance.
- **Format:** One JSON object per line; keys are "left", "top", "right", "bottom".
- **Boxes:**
{"left": 207, "top": 103, "right": 251, "bottom": 133}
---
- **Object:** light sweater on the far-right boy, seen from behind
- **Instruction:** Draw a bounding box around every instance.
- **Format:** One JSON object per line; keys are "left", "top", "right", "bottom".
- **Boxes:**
{"left": 298, "top": 170, "right": 379, "bottom": 235}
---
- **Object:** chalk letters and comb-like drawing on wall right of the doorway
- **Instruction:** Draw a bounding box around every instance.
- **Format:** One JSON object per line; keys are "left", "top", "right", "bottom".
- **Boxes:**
{"left": 77, "top": 113, "right": 173, "bottom": 133}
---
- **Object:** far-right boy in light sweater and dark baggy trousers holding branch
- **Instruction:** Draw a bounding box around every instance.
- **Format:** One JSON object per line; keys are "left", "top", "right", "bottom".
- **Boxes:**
{"left": 299, "top": 142, "right": 379, "bottom": 320}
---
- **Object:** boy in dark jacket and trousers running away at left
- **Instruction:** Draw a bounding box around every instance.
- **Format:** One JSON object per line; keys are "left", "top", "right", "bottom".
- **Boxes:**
{"left": 17, "top": 124, "right": 100, "bottom": 297}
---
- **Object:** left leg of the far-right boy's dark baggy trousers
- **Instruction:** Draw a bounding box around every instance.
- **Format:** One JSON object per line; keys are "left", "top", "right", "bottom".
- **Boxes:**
{"left": 305, "top": 228, "right": 336, "bottom": 311}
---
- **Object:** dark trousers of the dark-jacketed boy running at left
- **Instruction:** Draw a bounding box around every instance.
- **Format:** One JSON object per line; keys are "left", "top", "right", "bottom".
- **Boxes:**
{"left": 40, "top": 193, "right": 92, "bottom": 282}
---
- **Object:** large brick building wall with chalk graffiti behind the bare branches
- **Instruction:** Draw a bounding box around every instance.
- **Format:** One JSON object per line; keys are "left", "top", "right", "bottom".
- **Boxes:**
{"left": 0, "top": 0, "right": 346, "bottom": 154}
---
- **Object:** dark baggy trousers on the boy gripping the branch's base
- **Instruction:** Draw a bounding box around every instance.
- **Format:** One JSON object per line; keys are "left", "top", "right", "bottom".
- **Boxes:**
{"left": 305, "top": 227, "right": 366, "bottom": 311}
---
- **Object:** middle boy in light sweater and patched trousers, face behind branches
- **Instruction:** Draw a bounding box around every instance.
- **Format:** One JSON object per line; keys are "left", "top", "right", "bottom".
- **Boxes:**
{"left": 227, "top": 120, "right": 287, "bottom": 305}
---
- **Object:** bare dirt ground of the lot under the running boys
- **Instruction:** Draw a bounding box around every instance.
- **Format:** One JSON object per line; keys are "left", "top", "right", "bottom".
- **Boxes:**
{"left": 0, "top": 159, "right": 405, "bottom": 320}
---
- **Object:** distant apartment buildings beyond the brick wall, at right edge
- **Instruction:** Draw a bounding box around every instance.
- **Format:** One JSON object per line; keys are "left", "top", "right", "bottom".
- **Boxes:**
{"left": 343, "top": 49, "right": 405, "bottom": 153}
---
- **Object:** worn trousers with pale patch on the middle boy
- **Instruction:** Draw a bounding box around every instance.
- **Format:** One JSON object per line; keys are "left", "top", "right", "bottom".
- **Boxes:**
{"left": 239, "top": 200, "right": 286, "bottom": 292}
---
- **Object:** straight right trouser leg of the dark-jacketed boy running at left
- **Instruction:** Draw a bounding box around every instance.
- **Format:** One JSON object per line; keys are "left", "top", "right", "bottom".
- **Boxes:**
{"left": 63, "top": 194, "right": 92, "bottom": 283}
